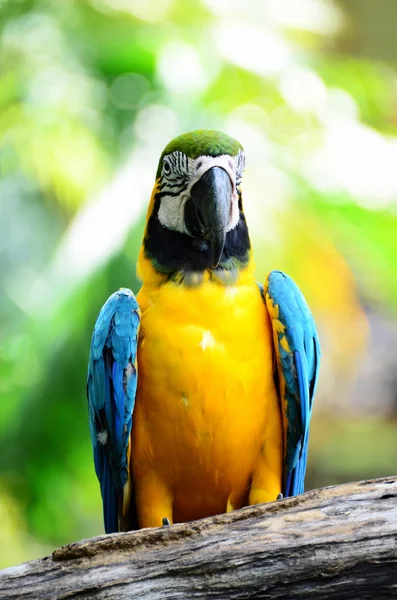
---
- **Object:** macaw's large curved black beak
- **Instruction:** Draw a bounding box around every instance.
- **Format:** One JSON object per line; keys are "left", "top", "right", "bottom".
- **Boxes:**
{"left": 185, "top": 167, "right": 233, "bottom": 268}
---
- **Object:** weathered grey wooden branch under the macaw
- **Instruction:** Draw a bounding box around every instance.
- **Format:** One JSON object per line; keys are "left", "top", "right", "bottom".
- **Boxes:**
{"left": 0, "top": 477, "right": 397, "bottom": 600}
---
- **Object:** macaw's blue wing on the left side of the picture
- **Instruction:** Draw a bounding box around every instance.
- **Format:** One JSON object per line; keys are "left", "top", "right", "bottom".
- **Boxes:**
{"left": 87, "top": 289, "right": 140, "bottom": 533}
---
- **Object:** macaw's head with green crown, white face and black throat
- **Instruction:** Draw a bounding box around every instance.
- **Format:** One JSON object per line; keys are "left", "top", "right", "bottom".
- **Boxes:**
{"left": 142, "top": 130, "right": 250, "bottom": 283}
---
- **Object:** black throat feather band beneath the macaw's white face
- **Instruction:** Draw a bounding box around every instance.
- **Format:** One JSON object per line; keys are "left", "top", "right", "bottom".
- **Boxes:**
{"left": 143, "top": 192, "right": 251, "bottom": 279}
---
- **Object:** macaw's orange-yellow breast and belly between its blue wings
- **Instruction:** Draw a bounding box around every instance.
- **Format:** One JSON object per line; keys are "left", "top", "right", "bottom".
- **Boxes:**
{"left": 131, "top": 267, "right": 279, "bottom": 526}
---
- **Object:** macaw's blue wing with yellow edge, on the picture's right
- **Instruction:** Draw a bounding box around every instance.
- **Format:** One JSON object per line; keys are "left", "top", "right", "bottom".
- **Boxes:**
{"left": 265, "top": 271, "right": 321, "bottom": 497}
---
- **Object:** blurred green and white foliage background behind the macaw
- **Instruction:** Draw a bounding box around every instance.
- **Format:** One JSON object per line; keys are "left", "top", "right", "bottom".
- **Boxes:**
{"left": 0, "top": 0, "right": 397, "bottom": 566}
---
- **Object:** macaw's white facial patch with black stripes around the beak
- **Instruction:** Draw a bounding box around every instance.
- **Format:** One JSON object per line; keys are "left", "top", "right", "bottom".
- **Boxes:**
{"left": 158, "top": 150, "right": 244, "bottom": 235}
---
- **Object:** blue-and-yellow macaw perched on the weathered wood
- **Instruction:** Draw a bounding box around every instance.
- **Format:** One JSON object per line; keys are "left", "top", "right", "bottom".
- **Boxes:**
{"left": 87, "top": 130, "right": 320, "bottom": 533}
